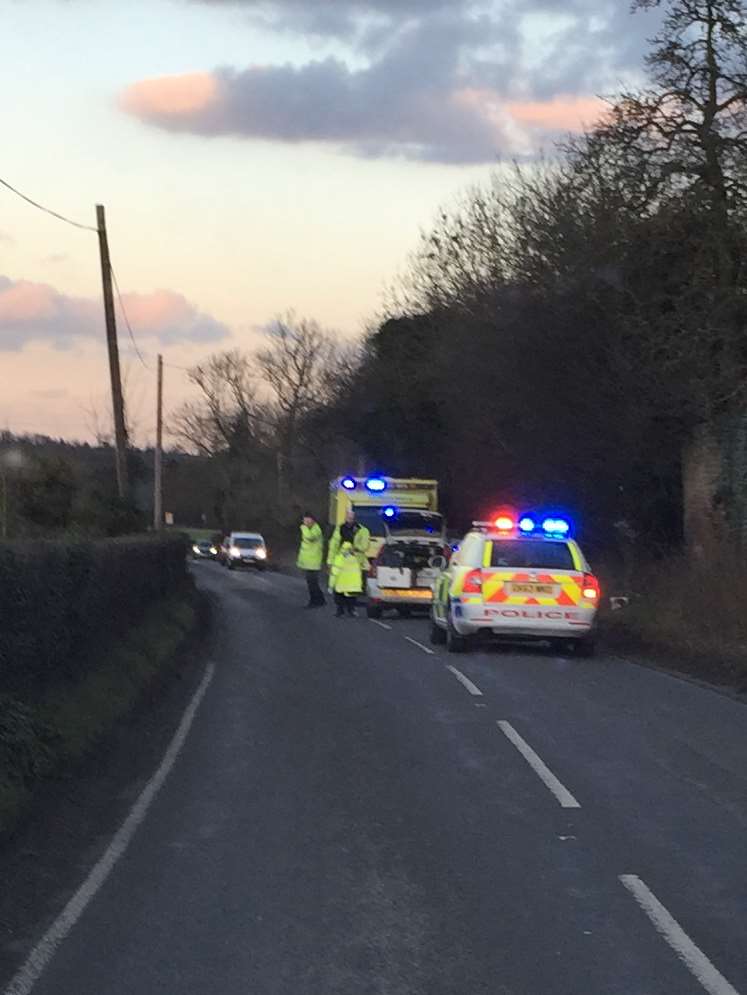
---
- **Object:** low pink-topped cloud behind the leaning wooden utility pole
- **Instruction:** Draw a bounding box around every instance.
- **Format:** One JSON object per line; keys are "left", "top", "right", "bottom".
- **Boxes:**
{"left": 0, "top": 275, "right": 230, "bottom": 352}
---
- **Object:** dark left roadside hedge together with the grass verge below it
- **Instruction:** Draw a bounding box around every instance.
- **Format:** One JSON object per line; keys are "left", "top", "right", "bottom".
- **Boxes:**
{"left": 0, "top": 536, "right": 195, "bottom": 833}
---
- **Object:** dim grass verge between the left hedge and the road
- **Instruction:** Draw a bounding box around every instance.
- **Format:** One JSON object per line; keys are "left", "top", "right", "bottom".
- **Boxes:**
{"left": 0, "top": 592, "right": 199, "bottom": 838}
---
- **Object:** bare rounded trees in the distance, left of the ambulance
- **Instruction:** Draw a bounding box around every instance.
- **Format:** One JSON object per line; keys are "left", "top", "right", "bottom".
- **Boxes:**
{"left": 171, "top": 313, "right": 356, "bottom": 527}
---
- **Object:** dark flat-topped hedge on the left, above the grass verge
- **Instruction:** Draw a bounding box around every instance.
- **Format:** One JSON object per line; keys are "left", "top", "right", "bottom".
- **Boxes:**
{"left": 0, "top": 536, "right": 189, "bottom": 697}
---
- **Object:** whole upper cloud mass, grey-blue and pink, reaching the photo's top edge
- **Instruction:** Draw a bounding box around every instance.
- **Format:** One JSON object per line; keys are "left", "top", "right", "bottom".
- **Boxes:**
{"left": 120, "top": 0, "right": 658, "bottom": 163}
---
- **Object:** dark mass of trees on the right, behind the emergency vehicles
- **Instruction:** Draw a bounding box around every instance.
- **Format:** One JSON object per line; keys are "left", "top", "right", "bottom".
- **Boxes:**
{"left": 324, "top": 0, "right": 747, "bottom": 555}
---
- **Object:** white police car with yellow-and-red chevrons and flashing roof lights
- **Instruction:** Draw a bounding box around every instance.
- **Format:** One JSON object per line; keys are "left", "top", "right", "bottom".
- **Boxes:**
{"left": 431, "top": 513, "right": 600, "bottom": 656}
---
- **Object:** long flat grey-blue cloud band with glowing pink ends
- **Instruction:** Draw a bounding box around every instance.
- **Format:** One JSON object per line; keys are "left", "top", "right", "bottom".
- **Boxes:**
{"left": 120, "top": 67, "right": 604, "bottom": 163}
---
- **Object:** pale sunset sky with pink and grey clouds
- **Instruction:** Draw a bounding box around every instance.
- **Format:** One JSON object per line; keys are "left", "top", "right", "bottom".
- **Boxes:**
{"left": 0, "top": 0, "right": 659, "bottom": 443}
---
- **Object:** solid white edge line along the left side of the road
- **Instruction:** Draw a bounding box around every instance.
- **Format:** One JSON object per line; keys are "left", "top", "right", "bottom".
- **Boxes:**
{"left": 4, "top": 663, "right": 215, "bottom": 995}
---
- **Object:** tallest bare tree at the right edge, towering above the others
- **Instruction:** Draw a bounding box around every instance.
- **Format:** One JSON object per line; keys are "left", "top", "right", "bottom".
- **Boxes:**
{"left": 571, "top": 0, "right": 747, "bottom": 555}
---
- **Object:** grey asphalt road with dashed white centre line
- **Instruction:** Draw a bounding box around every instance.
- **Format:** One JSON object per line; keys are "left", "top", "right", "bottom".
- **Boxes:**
{"left": 6, "top": 563, "right": 747, "bottom": 995}
